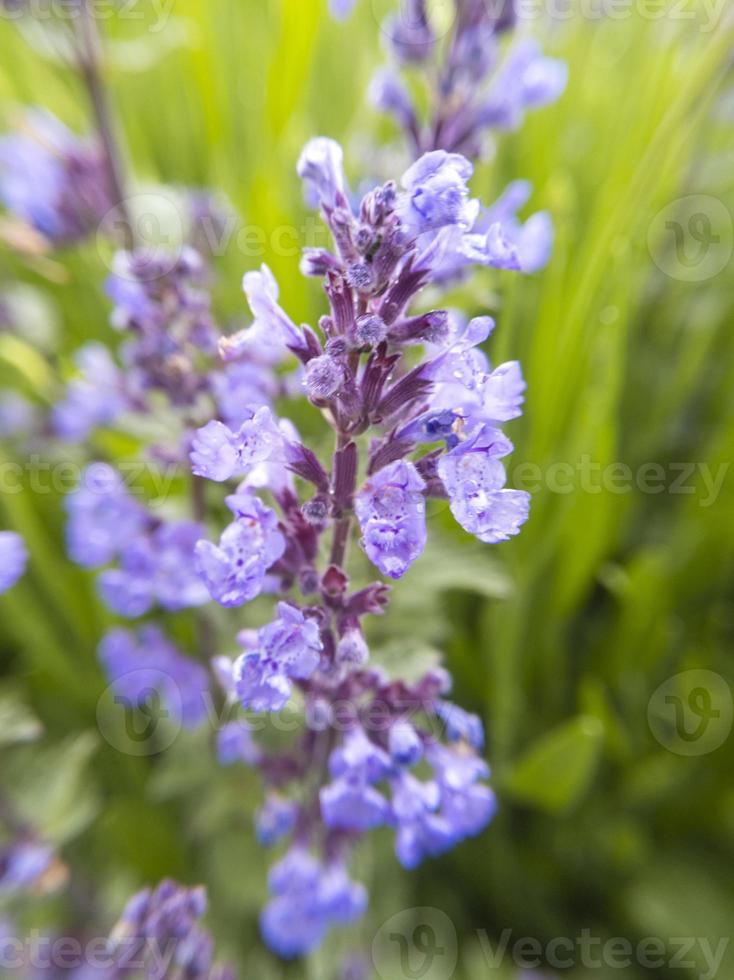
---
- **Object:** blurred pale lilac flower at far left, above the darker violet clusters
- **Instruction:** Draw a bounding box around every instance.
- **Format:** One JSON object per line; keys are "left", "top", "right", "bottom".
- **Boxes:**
{"left": 53, "top": 343, "right": 127, "bottom": 442}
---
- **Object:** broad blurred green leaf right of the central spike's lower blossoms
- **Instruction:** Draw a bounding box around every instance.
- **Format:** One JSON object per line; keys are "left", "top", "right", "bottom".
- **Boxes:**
{"left": 502, "top": 715, "right": 604, "bottom": 813}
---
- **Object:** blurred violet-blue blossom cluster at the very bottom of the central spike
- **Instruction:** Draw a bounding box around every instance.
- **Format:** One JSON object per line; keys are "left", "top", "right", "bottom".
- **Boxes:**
{"left": 260, "top": 847, "right": 367, "bottom": 959}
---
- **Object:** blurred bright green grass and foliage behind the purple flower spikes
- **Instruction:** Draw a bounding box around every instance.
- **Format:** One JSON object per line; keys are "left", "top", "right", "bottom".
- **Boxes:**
{"left": 0, "top": 0, "right": 734, "bottom": 980}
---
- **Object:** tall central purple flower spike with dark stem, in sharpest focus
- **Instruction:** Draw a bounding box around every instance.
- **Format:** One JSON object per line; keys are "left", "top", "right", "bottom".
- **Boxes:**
{"left": 191, "top": 42, "right": 548, "bottom": 944}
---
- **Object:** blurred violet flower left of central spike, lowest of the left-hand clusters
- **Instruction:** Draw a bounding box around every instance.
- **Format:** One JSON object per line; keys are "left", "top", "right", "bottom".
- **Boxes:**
{"left": 97, "top": 626, "right": 209, "bottom": 728}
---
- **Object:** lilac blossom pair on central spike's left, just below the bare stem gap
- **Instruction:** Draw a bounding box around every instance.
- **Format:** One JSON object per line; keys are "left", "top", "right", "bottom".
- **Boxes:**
{"left": 234, "top": 602, "right": 323, "bottom": 711}
